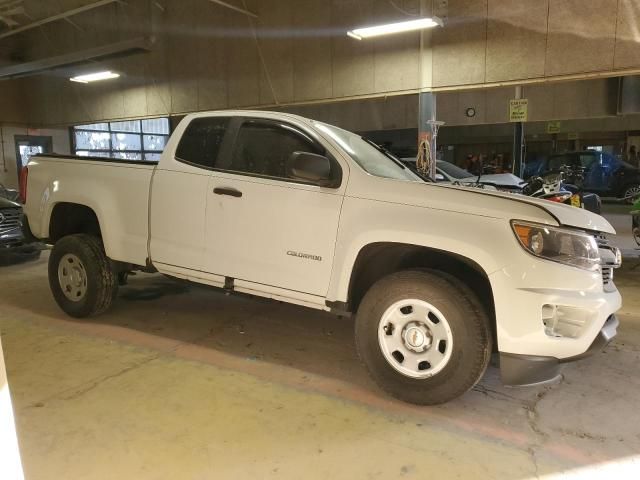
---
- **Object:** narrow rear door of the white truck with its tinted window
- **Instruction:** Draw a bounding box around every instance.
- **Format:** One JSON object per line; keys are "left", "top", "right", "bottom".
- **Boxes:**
{"left": 150, "top": 117, "right": 230, "bottom": 270}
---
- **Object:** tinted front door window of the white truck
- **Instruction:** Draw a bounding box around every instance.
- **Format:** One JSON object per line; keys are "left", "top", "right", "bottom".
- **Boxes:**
{"left": 223, "top": 120, "right": 324, "bottom": 179}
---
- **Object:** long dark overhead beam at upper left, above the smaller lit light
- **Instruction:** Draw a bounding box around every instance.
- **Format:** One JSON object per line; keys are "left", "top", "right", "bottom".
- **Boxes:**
{"left": 0, "top": 37, "right": 153, "bottom": 80}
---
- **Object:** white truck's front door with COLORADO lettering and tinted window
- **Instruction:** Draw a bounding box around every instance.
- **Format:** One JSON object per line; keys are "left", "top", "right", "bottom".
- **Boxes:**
{"left": 206, "top": 118, "right": 344, "bottom": 296}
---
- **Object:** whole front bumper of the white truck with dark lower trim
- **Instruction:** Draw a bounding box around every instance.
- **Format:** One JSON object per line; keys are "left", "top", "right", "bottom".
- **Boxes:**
{"left": 489, "top": 240, "right": 622, "bottom": 385}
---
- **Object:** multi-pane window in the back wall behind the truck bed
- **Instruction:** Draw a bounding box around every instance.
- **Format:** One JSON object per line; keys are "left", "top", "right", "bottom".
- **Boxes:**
{"left": 73, "top": 118, "right": 169, "bottom": 161}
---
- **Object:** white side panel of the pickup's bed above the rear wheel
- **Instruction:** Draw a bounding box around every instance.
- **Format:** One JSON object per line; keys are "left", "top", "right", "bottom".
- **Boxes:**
{"left": 25, "top": 154, "right": 157, "bottom": 265}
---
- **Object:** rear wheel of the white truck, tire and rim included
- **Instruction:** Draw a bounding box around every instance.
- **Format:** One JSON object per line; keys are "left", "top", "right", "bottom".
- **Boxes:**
{"left": 49, "top": 234, "right": 118, "bottom": 318}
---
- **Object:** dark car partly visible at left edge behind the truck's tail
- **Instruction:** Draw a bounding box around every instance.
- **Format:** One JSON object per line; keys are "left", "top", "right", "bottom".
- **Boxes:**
{"left": 0, "top": 196, "right": 41, "bottom": 265}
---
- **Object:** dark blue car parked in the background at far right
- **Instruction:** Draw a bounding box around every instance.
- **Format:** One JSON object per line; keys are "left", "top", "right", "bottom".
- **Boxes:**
{"left": 529, "top": 150, "right": 640, "bottom": 203}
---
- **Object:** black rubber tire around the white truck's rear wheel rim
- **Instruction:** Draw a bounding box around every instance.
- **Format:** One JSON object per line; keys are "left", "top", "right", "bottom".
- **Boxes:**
{"left": 49, "top": 234, "right": 118, "bottom": 318}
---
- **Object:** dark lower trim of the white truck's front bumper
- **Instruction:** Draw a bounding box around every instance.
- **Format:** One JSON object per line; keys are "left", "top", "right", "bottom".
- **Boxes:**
{"left": 500, "top": 315, "right": 620, "bottom": 386}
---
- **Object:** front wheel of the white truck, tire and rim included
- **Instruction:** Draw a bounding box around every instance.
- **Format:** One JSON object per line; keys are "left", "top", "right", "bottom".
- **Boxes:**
{"left": 356, "top": 270, "right": 492, "bottom": 405}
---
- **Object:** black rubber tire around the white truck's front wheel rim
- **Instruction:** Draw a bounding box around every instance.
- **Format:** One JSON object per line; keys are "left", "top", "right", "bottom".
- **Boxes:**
{"left": 355, "top": 270, "right": 493, "bottom": 405}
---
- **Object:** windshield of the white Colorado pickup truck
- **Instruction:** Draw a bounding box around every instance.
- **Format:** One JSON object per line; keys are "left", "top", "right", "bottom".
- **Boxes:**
{"left": 315, "top": 122, "right": 422, "bottom": 182}
